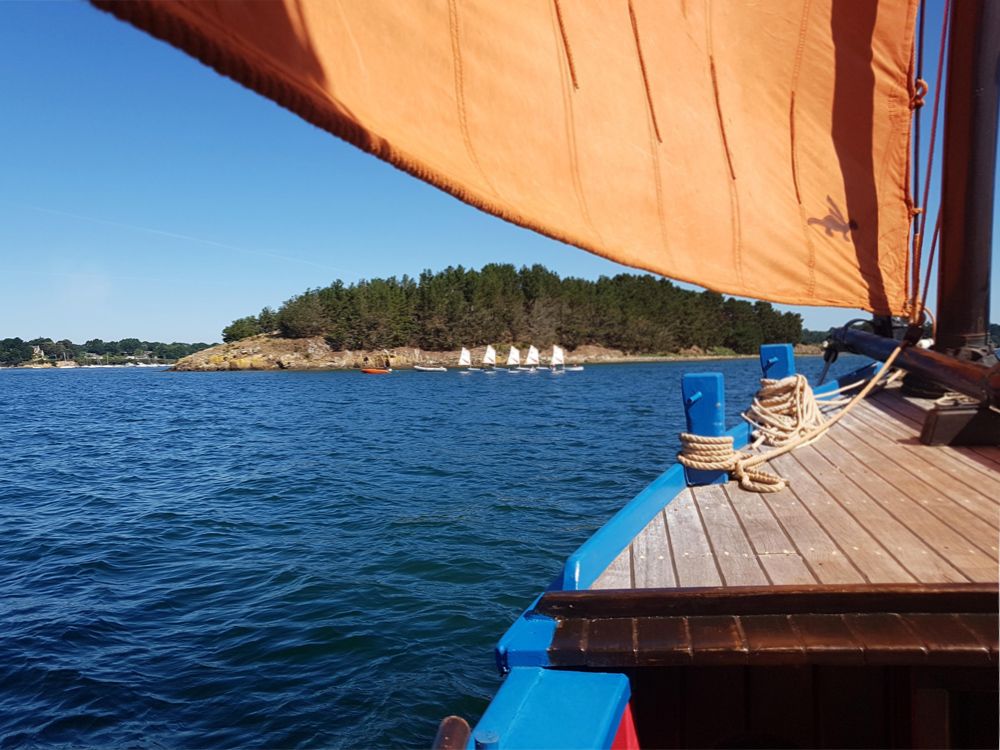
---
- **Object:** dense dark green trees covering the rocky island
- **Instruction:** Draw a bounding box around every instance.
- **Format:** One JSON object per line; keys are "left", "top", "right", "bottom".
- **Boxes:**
{"left": 222, "top": 263, "right": 803, "bottom": 353}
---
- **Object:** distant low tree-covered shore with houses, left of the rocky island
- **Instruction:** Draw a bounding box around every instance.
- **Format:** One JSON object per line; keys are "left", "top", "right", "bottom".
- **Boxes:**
{"left": 0, "top": 338, "right": 211, "bottom": 365}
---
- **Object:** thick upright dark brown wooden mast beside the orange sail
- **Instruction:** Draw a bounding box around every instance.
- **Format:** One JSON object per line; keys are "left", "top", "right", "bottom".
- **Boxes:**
{"left": 935, "top": 0, "right": 1000, "bottom": 364}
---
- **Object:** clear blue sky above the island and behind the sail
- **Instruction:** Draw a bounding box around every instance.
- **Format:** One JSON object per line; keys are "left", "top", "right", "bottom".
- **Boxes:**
{"left": 0, "top": 2, "right": 1000, "bottom": 342}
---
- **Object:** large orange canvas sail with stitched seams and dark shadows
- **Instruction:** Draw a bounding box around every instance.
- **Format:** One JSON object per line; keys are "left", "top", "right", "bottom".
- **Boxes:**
{"left": 93, "top": 0, "right": 916, "bottom": 314}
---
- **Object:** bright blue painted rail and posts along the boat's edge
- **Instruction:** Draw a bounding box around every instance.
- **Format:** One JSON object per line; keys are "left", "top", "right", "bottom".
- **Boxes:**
{"left": 480, "top": 352, "right": 877, "bottom": 750}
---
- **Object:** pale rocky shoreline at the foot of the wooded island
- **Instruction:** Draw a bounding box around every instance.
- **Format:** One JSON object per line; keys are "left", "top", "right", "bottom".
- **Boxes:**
{"left": 172, "top": 334, "right": 819, "bottom": 372}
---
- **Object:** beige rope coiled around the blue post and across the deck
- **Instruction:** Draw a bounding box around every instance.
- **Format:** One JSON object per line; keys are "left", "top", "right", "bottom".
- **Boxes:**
{"left": 677, "top": 342, "right": 906, "bottom": 492}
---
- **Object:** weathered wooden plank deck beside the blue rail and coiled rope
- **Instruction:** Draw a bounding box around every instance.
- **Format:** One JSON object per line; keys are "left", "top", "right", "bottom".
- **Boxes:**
{"left": 592, "top": 390, "right": 1000, "bottom": 589}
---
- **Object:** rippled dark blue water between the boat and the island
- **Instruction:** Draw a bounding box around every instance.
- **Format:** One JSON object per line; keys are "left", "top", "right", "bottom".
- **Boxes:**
{"left": 0, "top": 358, "right": 860, "bottom": 748}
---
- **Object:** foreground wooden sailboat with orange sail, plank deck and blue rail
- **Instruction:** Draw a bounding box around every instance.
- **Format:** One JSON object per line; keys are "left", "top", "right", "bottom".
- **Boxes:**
{"left": 94, "top": 0, "right": 1000, "bottom": 748}
